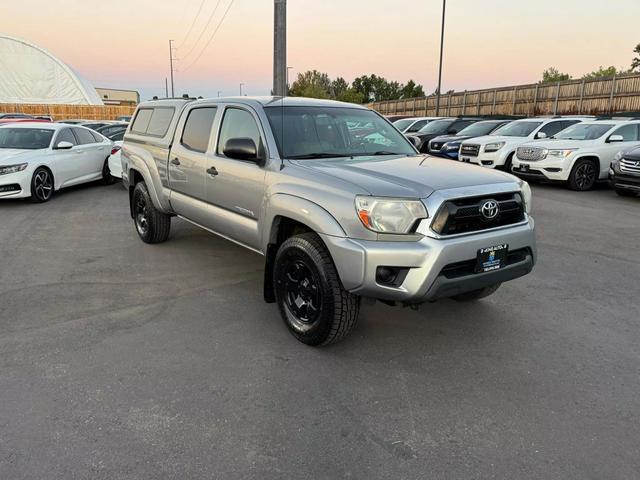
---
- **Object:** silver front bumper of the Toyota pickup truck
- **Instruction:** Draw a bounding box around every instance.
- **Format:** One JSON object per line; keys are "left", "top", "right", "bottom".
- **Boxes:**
{"left": 321, "top": 217, "right": 537, "bottom": 304}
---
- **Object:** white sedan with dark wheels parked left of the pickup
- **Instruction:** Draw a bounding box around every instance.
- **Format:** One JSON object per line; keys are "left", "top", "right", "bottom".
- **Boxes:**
{"left": 0, "top": 123, "right": 114, "bottom": 203}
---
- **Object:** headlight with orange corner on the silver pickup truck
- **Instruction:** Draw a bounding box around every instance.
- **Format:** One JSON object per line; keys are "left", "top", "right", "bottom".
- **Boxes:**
{"left": 356, "top": 196, "right": 429, "bottom": 233}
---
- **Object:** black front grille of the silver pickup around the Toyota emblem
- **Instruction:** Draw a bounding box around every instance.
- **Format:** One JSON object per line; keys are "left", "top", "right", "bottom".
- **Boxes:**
{"left": 431, "top": 193, "right": 525, "bottom": 235}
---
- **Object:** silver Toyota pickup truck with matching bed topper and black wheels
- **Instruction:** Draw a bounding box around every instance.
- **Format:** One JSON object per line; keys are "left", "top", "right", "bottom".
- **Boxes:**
{"left": 122, "top": 97, "right": 537, "bottom": 345}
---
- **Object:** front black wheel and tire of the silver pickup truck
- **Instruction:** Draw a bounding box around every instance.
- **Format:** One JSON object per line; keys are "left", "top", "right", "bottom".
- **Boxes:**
{"left": 273, "top": 233, "right": 360, "bottom": 346}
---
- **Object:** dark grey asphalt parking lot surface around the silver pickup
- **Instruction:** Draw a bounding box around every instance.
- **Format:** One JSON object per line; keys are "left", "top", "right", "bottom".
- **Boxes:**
{"left": 0, "top": 185, "right": 640, "bottom": 480}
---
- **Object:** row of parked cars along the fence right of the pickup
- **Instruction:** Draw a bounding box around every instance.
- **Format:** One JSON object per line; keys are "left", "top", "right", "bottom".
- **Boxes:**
{"left": 394, "top": 116, "right": 640, "bottom": 195}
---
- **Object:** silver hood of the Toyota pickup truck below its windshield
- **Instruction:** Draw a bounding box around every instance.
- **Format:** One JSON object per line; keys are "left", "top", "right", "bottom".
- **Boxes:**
{"left": 291, "top": 155, "right": 517, "bottom": 198}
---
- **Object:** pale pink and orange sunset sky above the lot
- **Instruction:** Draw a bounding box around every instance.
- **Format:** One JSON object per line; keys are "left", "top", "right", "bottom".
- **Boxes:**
{"left": 0, "top": 0, "right": 640, "bottom": 99}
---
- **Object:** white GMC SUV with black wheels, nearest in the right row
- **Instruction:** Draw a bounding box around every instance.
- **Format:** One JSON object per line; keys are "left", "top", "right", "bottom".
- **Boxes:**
{"left": 512, "top": 120, "right": 640, "bottom": 191}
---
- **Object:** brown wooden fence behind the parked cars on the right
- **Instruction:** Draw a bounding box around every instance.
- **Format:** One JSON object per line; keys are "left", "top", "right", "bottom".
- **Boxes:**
{"left": 369, "top": 74, "right": 640, "bottom": 117}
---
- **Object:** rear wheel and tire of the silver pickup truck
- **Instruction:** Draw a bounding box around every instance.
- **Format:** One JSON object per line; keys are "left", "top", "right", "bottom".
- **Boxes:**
{"left": 131, "top": 182, "right": 171, "bottom": 243}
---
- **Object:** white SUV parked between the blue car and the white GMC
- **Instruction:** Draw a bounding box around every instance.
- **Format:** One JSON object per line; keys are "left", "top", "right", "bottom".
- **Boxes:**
{"left": 458, "top": 117, "right": 592, "bottom": 172}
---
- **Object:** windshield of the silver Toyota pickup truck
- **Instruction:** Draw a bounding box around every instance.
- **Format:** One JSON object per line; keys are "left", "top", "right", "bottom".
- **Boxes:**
{"left": 265, "top": 106, "right": 416, "bottom": 159}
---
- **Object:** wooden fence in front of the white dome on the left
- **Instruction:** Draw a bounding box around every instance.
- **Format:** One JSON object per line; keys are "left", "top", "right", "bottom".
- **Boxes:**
{"left": 0, "top": 103, "right": 136, "bottom": 120}
